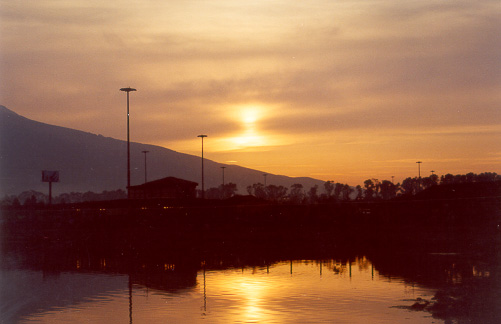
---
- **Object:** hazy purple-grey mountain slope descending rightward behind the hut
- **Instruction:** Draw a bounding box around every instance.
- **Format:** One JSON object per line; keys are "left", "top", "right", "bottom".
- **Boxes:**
{"left": 0, "top": 105, "right": 324, "bottom": 196}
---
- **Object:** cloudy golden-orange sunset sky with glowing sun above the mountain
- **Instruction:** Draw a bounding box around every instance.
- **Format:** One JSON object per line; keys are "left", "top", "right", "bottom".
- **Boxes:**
{"left": 0, "top": 0, "right": 501, "bottom": 185}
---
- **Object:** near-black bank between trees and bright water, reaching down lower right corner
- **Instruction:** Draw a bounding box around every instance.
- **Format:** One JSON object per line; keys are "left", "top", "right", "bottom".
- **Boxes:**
{"left": 1, "top": 198, "right": 501, "bottom": 323}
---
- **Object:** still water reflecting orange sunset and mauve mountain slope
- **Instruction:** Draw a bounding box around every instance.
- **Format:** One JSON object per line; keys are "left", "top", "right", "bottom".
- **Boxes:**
{"left": 1, "top": 258, "right": 443, "bottom": 323}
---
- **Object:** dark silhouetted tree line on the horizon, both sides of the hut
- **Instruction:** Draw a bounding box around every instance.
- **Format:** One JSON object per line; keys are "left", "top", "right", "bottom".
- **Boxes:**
{"left": 0, "top": 172, "right": 501, "bottom": 206}
